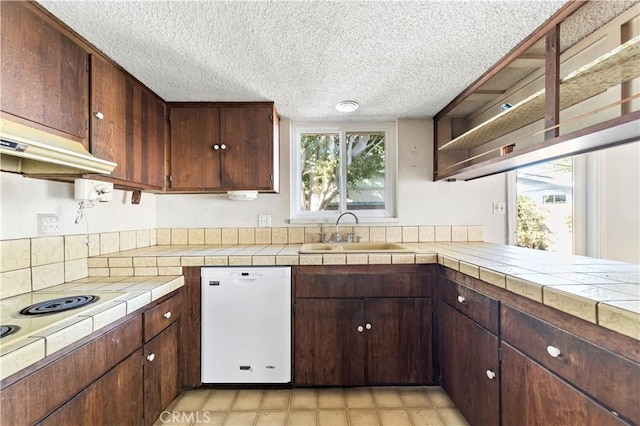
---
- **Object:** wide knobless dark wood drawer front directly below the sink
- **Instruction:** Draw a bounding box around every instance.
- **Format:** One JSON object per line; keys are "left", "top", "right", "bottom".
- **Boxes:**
{"left": 295, "top": 265, "right": 431, "bottom": 299}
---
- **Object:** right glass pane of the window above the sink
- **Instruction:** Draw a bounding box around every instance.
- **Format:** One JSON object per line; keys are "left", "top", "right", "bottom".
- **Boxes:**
{"left": 346, "top": 132, "right": 386, "bottom": 210}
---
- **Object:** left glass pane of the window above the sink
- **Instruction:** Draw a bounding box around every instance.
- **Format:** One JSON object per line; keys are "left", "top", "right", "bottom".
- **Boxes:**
{"left": 300, "top": 133, "right": 340, "bottom": 211}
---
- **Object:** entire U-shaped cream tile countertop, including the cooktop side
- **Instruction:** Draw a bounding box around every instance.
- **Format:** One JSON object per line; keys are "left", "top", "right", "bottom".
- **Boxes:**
{"left": 0, "top": 242, "right": 640, "bottom": 379}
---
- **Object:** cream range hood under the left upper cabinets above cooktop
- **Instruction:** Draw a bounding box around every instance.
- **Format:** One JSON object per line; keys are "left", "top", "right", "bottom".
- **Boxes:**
{"left": 0, "top": 117, "right": 117, "bottom": 174}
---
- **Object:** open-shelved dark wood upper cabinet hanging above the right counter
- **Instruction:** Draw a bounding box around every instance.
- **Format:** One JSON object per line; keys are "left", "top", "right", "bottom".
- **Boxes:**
{"left": 434, "top": 1, "right": 640, "bottom": 180}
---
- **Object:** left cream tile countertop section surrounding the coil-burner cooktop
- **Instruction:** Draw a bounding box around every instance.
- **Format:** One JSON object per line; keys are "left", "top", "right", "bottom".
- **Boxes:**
{"left": 0, "top": 276, "right": 184, "bottom": 380}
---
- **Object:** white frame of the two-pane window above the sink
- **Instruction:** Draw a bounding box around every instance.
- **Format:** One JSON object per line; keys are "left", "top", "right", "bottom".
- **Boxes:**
{"left": 289, "top": 122, "right": 398, "bottom": 223}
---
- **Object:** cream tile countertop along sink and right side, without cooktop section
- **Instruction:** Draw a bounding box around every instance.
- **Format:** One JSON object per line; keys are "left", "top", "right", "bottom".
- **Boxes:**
{"left": 89, "top": 242, "right": 640, "bottom": 340}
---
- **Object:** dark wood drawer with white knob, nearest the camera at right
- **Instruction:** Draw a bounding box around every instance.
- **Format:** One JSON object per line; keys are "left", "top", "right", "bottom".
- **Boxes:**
{"left": 501, "top": 305, "right": 640, "bottom": 424}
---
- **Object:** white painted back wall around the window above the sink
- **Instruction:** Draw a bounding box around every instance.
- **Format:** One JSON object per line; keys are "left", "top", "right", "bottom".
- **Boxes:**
{"left": 157, "top": 119, "right": 506, "bottom": 243}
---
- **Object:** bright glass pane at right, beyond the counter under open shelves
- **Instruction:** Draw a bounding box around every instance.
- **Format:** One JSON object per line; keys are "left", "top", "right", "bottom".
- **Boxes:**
{"left": 516, "top": 158, "right": 573, "bottom": 254}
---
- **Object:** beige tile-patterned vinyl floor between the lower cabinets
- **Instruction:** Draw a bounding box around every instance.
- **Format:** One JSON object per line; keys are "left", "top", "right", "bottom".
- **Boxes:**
{"left": 160, "top": 386, "right": 468, "bottom": 426}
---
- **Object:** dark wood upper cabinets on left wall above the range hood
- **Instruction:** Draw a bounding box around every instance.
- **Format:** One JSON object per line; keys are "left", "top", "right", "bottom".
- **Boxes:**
{"left": 0, "top": 1, "right": 167, "bottom": 190}
